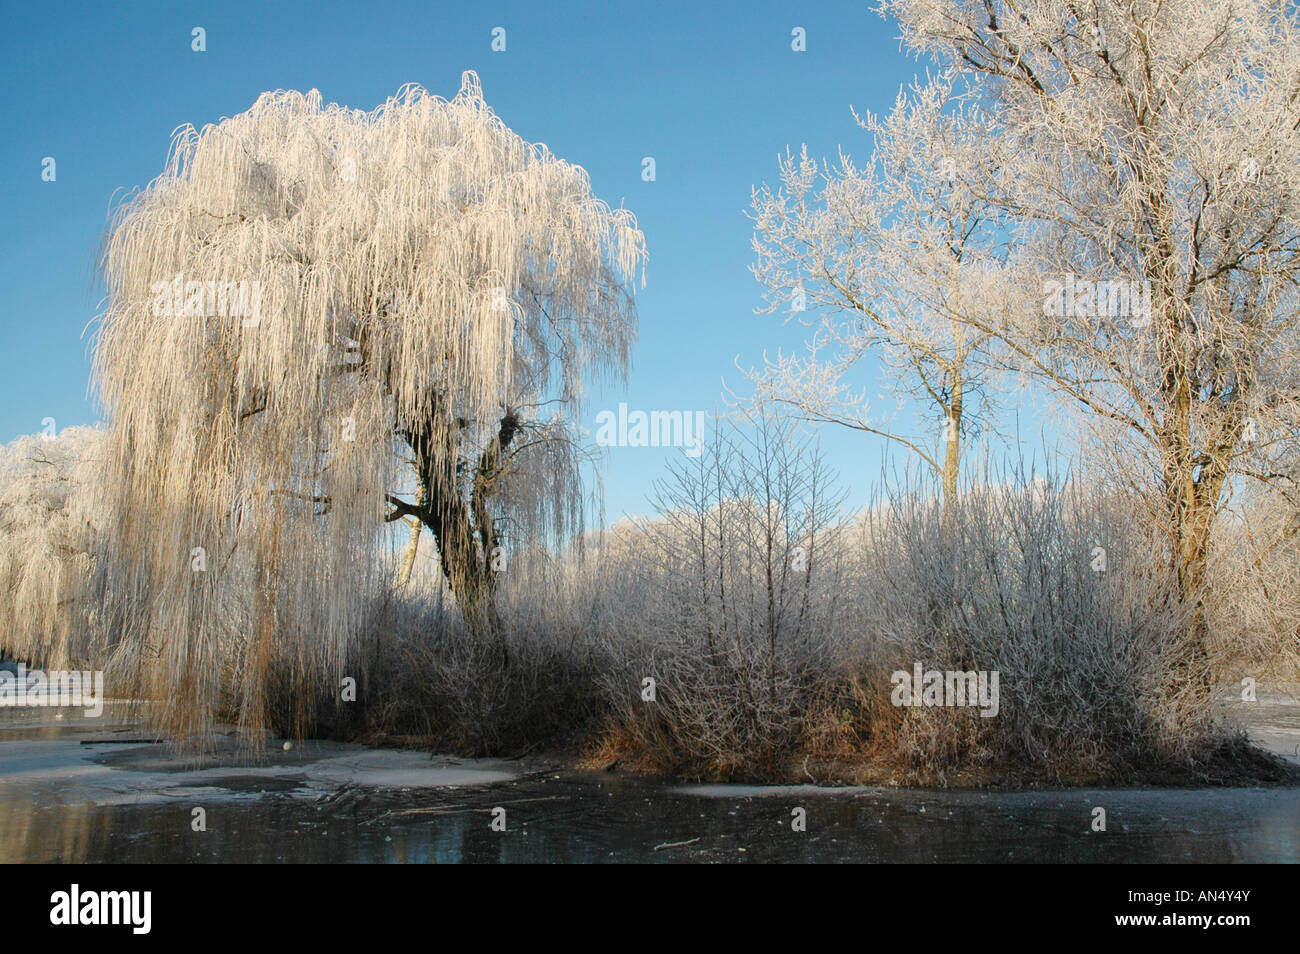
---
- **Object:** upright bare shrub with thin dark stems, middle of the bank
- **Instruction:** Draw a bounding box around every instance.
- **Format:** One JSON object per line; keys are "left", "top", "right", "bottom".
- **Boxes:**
{"left": 595, "top": 408, "right": 841, "bottom": 776}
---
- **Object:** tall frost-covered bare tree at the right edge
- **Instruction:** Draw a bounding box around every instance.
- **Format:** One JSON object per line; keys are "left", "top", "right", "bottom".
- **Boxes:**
{"left": 880, "top": 0, "right": 1300, "bottom": 685}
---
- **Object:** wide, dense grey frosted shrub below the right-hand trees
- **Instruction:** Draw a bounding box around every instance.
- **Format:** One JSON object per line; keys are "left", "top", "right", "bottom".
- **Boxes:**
{"left": 855, "top": 462, "right": 1218, "bottom": 779}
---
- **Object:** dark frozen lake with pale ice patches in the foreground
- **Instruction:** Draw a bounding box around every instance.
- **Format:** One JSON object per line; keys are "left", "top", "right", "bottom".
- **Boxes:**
{"left": 0, "top": 695, "right": 1300, "bottom": 863}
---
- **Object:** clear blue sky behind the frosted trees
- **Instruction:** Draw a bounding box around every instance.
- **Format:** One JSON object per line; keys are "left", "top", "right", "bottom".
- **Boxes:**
{"left": 0, "top": 0, "right": 1045, "bottom": 520}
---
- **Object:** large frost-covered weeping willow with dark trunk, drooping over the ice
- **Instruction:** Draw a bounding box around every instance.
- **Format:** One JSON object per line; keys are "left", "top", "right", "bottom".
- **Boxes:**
{"left": 95, "top": 73, "right": 645, "bottom": 736}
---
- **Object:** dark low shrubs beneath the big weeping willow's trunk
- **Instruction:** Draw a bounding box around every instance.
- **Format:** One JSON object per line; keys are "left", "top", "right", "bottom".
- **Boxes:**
{"left": 343, "top": 548, "right": 608, "bottom": 755}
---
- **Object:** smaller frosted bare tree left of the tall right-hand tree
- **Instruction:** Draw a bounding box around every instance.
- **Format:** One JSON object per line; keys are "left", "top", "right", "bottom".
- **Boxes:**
{"left": 751, "top": 74, "right": 1005, "bottom": 509}
